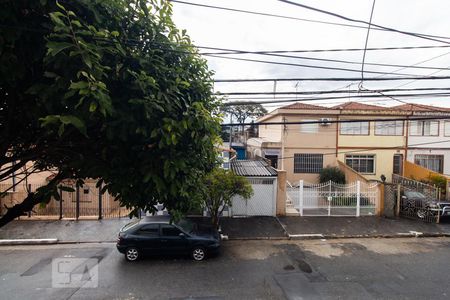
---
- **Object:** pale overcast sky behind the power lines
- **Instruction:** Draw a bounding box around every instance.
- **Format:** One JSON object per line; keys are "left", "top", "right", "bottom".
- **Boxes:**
{"left": 173, "top": 0, "right": 450, "bottom": 110}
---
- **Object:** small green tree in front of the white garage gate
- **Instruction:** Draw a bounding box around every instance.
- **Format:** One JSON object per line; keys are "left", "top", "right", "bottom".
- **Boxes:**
{"left": 201, "top": 168, "right": 253, "bottom": 228}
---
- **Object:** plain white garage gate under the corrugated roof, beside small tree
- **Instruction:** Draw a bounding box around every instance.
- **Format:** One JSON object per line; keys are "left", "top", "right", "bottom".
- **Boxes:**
{"left": 230, "top": 177, "right": 277, "bottom": 216}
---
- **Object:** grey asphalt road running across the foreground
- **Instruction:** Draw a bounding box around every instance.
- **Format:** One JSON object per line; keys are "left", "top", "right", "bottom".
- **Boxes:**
{"left": 0, "top": 238, "right": 450, "bottom": 299}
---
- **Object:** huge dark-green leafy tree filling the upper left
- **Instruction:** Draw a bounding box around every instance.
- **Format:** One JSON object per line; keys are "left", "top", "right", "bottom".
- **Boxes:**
{"left": 0, "top": 0, "right": 220, "bottom": 226}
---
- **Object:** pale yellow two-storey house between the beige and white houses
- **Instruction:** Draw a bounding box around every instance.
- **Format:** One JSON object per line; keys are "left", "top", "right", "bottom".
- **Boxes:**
{"left": 333, "top": 102, "right": 408, "bottom": 181}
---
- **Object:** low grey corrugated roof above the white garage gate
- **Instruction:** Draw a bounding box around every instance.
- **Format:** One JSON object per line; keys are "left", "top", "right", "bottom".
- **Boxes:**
{"left": 230, "top": 160, "right": 278, "bottom": 177}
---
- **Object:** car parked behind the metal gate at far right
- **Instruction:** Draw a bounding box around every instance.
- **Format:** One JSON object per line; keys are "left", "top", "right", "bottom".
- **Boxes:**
{"left": 401, "top": 191, "right": 450, "bottom": 219}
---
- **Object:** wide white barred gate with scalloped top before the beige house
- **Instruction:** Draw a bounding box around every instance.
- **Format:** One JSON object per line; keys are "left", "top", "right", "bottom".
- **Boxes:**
{"left": 287, "top": 180, "right": 379, "bottom": 217}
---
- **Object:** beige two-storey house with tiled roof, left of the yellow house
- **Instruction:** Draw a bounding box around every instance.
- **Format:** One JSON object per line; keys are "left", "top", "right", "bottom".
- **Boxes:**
{"left": 247, "top": 103, "right": 339, "bottom": 183}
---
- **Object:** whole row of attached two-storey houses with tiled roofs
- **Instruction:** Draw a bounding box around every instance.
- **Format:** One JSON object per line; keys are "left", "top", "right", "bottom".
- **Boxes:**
{"left": 247, "top": 102, "right": 450, "bottom": 183}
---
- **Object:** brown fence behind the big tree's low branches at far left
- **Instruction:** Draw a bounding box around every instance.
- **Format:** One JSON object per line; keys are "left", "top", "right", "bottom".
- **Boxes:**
{"left": 0, "top": 184, "right": 130, "bottom": 220}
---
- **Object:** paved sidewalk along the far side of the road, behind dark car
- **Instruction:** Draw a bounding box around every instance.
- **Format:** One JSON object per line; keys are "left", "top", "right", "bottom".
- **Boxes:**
{"left": 0, "top": 217, "right": 450, "bottom": 243}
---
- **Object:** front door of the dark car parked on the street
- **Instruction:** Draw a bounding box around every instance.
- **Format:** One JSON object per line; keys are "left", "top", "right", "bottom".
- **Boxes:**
{"left": 161, "top": 224, "right": 189, "bottom": 254}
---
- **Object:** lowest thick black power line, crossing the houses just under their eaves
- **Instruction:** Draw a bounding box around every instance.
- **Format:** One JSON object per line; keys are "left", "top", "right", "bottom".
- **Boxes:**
{"left": 221, "top": 115, "right": 450, "bottom": 127}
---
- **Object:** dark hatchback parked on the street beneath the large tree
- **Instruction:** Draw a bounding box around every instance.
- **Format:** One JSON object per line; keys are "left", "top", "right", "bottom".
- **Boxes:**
{"left": 117, "top": 216, "right": 220, "bottom": 261}
